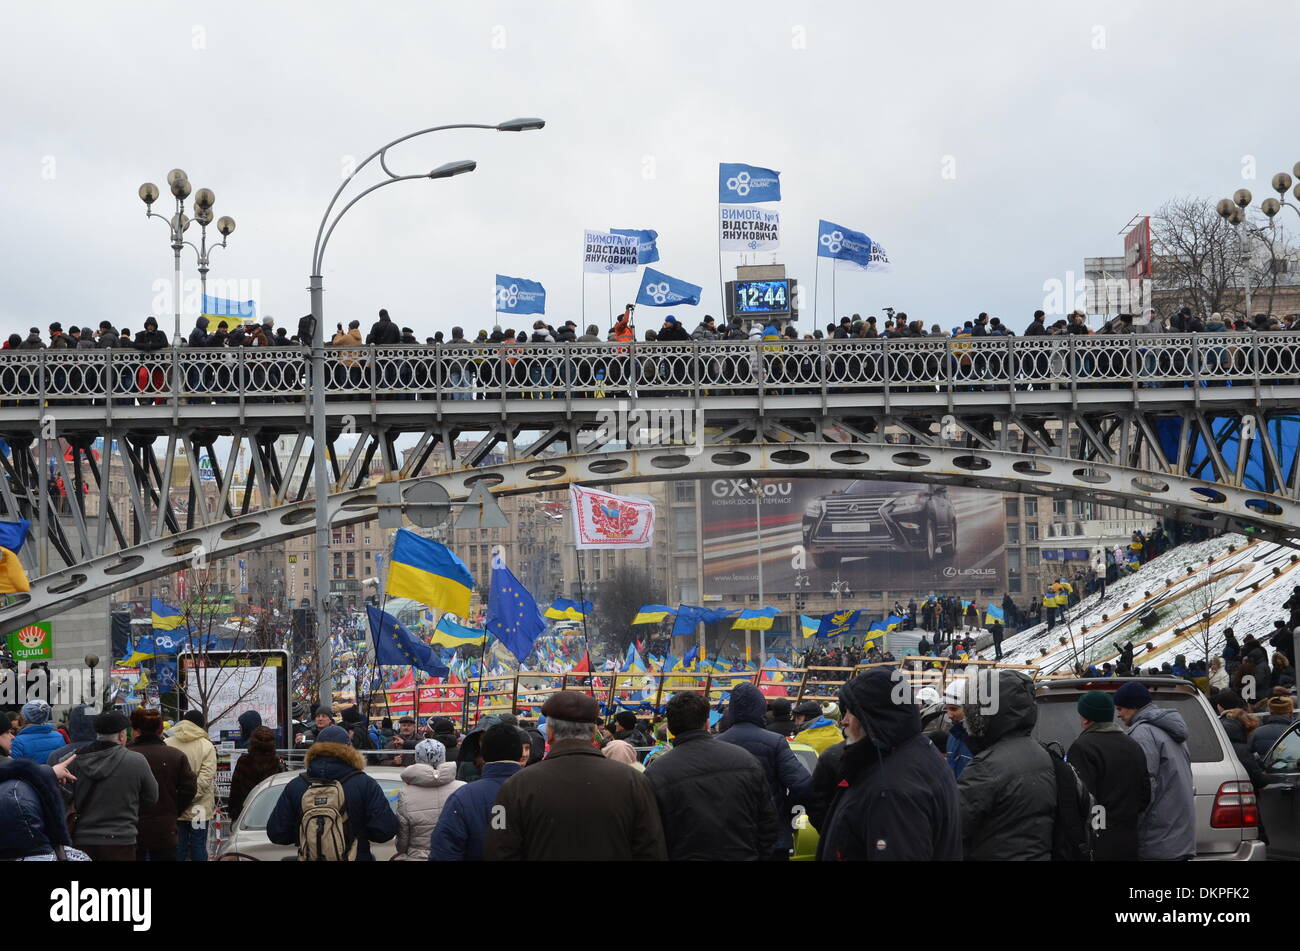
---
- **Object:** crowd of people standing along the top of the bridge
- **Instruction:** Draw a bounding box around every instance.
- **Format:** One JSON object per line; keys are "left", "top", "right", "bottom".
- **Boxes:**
{"left": 0, "top": 304, "right": 1300, "bottom": 401}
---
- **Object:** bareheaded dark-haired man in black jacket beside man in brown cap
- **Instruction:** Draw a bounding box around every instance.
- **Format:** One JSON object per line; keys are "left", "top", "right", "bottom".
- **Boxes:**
{"left": 646, "top": 692, "right": 777, "bottom": 861}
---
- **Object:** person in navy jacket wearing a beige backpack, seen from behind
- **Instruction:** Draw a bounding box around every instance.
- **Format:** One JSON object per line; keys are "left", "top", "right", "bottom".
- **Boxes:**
{"left": 267, "top": 726, "right": 398, "bottom": 861}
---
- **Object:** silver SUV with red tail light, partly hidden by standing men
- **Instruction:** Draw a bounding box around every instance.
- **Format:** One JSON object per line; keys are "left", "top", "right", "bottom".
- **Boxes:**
{"left": 1034, "top": 677, "right": 1265, "bottom": 861}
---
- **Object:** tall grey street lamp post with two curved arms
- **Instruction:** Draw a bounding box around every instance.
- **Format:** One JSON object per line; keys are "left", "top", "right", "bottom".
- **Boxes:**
{"left": 308, "top": 118, "right": 546, "bottom": 703}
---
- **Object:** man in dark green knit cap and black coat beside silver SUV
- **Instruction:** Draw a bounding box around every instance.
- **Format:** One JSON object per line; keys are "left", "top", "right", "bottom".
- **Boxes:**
{"left": 1066, "top": 690, "right": 1151, "bottom": 861}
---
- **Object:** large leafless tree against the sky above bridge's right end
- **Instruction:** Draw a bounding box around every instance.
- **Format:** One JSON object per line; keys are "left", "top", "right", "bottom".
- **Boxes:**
{"left": 1152, "top": 197, "right": 1294, "bottom": 317}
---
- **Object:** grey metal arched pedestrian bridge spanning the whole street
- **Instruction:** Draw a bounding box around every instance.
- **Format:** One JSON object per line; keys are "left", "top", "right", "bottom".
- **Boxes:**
{"left": 0, "top": 333, "right": 1300, "bottom": 625}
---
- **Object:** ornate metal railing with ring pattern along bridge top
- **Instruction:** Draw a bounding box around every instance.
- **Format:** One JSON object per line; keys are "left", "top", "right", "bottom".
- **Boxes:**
{"left": 0, "top": 331, "right": 1300, "bottom": 405}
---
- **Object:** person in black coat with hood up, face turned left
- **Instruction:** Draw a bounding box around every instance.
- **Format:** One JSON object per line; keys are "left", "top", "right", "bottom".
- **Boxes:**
{"left": 818, "top": 668, "right": 962, "bottom": 861}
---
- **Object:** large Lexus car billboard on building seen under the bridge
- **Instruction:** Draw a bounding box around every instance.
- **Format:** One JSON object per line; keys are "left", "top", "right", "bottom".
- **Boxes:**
{"left": 701, "top": 479, "right": 1006, "bottom": 596}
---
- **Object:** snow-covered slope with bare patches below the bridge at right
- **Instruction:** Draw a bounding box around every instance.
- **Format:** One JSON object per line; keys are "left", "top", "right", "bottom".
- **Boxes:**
{"left": 980, "top": 534, "right": 1300, "bottom": 674}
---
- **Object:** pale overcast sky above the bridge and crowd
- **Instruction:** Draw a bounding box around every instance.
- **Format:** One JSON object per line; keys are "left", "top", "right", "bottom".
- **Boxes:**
{"left": 0, "top": 0, "right": 1300, "bottom": 339}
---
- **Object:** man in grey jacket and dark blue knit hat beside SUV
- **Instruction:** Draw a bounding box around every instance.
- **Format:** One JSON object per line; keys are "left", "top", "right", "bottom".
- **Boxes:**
{"left": 1115, "top": 681, "right": 1196, "bottom": 861}
